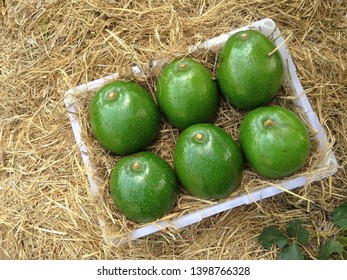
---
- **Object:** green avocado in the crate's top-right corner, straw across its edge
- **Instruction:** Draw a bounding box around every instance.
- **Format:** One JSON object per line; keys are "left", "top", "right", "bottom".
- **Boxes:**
{"left": 216, "top": 30, "right": 283, "bottom": 109}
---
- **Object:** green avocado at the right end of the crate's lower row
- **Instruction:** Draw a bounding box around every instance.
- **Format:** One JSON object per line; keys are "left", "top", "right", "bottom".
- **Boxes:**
{"left": 239, "top": 106, "right": 310, "bottom": 178}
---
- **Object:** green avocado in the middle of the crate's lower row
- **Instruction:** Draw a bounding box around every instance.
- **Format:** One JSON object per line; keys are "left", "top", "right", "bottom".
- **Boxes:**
{"left": 174, "top": 124, "right": 244, "bottom": 199}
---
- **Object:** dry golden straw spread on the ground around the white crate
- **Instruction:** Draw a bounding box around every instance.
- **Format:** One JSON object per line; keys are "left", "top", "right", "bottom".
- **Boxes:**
{"left": 0, "top": 0, "right": 347, "bottom": 259}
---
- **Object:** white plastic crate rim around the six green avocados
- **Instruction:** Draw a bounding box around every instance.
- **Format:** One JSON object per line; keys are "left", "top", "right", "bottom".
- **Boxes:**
{"left": 64, "top": 18, "right": 338, "bottom": 243}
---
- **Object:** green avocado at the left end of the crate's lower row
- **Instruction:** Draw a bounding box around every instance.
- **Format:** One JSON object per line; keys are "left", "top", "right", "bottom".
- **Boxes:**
{"left": 110, "top": 151, "right": 178, "bottom": 223}
